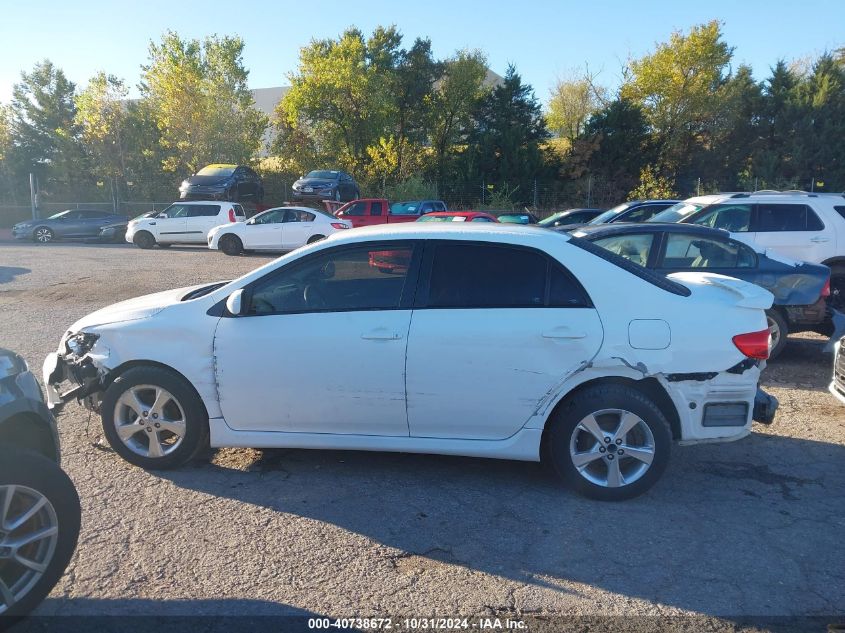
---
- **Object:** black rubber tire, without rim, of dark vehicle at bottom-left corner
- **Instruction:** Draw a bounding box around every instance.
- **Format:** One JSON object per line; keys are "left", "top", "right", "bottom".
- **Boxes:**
{"left": 0, "top": 450, "right": 81, "bottom": 616}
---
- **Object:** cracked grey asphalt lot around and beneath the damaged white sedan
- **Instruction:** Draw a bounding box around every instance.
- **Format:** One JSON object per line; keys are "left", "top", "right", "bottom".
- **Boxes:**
{"left": 0, "top": 243, "right": 845, "bottom": 620}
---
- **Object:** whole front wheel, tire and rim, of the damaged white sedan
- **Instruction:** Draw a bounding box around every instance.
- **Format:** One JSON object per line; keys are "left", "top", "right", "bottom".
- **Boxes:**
{"left": 101, "top": 366, "right": 208, "bottom": 470}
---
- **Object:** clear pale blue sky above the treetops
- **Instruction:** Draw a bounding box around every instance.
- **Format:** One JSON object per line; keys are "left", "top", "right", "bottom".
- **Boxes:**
{"left": 0, "top": 0, "right": 845, "bottom": 103}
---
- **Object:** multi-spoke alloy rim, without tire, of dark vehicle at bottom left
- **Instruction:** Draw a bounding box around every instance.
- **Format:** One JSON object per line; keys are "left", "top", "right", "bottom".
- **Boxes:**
{"left": 0, "top": 484, "right": 59, "bottom": 615}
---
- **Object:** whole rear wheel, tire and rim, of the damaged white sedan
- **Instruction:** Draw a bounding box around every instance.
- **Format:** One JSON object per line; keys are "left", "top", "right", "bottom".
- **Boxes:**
{"left": 544, "top": 384, "right": 672, "bottom": 501}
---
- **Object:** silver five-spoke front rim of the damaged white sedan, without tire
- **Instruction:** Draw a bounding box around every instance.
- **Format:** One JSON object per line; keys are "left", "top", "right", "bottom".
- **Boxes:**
{"left": 114, "top": 385, "right": 187, "bottom": 458}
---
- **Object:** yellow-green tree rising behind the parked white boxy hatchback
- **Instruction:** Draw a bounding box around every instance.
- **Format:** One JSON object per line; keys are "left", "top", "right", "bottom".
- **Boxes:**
{"left": 141, "top": 31, "right": 267, "bottom": 173}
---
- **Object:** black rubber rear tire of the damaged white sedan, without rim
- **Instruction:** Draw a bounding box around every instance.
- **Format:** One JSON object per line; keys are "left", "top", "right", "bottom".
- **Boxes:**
{"left": 543, "top": 383, "right": 672, "bottom": 501}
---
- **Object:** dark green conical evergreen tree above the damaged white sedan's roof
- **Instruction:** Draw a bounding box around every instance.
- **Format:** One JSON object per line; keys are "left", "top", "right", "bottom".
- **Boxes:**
{"left": 467, "top": 66, "right": 549, "bottom": 199}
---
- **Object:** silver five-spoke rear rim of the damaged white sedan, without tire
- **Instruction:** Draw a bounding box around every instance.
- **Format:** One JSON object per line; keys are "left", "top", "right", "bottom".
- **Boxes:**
{"left": 569, "top": 409, "right": 656, "bottom": 488}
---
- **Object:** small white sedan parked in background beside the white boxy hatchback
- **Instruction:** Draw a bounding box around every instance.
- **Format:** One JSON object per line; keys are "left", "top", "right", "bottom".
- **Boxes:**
{"left": 208, "top": 207, "right": 352, "bottom": 255}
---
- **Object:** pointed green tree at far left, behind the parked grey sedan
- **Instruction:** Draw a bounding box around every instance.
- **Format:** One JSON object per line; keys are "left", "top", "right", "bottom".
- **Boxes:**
{"left": 10, "top": 60, "right": 82, "bottom": 195}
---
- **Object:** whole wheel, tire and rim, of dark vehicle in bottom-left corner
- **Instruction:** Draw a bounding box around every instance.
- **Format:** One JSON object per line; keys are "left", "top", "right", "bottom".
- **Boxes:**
{"left": 0, "top": 450, "right": 81, "bottom": 616}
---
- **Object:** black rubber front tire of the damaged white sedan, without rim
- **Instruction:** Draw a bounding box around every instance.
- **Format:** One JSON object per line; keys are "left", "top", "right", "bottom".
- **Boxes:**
{"left": 100, "top": 366, "right": 208, "bottom": 470}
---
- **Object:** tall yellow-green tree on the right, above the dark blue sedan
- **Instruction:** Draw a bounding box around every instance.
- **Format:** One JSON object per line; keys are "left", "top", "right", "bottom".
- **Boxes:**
{"left": 620, "top": 21, "right": 732, "bottom": 173}
